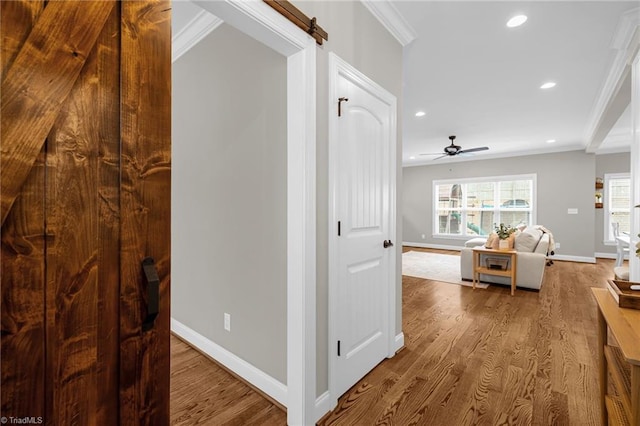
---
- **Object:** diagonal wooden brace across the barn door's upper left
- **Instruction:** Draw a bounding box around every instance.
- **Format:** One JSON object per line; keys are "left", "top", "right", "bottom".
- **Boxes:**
{"left": 0, "top": 0, "right": 114, "bottom": 223}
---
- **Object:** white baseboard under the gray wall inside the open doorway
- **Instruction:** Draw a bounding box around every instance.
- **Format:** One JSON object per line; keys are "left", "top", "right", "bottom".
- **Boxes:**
{"left": 171, "top": 318, "right": 287, "bottom": 407}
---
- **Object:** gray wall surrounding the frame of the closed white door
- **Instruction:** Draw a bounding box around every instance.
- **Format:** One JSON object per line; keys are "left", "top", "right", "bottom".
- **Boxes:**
{"left": 296, "top": 1, "right": 402, "bottom": 395}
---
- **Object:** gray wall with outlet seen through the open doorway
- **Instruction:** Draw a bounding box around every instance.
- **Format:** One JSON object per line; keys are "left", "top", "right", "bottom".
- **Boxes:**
{"left": 171, "top": 24, "right": 287, "bottom": 383}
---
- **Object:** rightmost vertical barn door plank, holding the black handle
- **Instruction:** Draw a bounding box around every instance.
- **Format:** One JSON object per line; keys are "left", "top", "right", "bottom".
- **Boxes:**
{"left": 120, "top": 0, "right": 171, "bottom": 426}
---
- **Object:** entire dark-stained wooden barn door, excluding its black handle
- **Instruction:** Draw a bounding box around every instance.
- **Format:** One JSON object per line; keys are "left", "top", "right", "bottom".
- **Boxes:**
{"left": 0, "top": 0, "right": 171, "bottom": 425}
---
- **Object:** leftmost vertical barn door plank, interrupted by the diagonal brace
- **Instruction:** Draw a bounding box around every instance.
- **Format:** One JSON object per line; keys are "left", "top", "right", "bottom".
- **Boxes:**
{"left": 0, "top": 1, "right": 45, "bottom": 418}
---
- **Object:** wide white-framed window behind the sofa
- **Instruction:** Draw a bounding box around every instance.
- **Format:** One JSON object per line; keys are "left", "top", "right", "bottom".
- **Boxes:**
{"left": 433, "top": 175, "right": 536, "bottom": 238}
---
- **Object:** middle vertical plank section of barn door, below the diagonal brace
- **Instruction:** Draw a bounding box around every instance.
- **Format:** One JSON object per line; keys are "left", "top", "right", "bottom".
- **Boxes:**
{"left": 46, "top": 8, "right": 120, "bottom": 425}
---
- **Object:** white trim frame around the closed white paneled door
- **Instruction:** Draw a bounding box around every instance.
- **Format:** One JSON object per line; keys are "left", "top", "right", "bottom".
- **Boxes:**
{"left": 328, "top": 52, "right": 400, "bottom": 407}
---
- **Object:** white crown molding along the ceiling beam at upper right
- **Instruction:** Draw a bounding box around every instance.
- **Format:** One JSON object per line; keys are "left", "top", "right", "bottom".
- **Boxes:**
{"left": 585, "top": 8, "right": 640, "bottom": 153}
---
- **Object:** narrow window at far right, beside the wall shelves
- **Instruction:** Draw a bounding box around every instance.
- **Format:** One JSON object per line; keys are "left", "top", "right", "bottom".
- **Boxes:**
{"left": 604, "top": 173, "right": 631, "bottom": 244}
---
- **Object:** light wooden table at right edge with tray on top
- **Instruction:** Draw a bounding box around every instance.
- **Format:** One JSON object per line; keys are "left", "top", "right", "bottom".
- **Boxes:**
{"left": 591, "top": 288, "right": 640, "bottom": 426}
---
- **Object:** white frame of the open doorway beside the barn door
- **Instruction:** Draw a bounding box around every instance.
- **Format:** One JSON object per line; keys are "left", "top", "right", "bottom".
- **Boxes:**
{"left": 194, "top": 0, "right": 316, "bottom": 425}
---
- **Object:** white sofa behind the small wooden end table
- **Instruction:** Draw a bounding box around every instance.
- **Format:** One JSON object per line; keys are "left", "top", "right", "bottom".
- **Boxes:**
{"left": 460, "top": 229, "right": 549, "bottom": 290}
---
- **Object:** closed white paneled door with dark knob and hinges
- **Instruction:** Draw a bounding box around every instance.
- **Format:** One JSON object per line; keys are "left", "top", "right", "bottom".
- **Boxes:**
{"left": 334, "top": 68, "right": 393, "bottom": 395}
